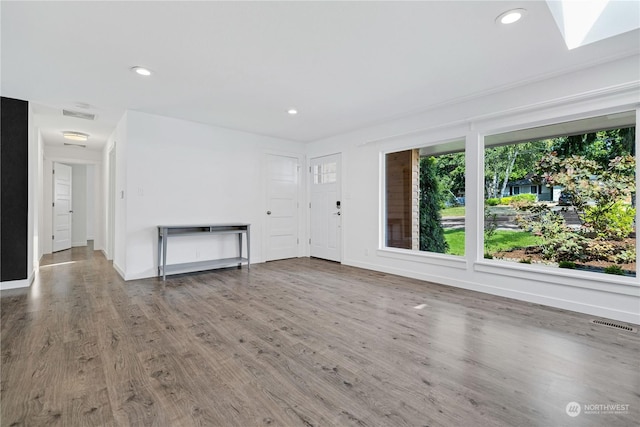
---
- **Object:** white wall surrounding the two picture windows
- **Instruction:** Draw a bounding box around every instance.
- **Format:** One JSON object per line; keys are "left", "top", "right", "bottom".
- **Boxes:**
{"left": 307, "top": 56, "right": 640, "bottom": 323}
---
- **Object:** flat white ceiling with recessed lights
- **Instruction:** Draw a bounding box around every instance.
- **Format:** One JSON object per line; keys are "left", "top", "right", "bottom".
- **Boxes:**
{"left": 0, "top": 1, "right": 640, "bottom": 149}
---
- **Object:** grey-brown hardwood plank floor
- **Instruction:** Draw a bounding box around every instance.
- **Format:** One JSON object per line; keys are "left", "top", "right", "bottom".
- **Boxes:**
{"left": 0, "top": 248, "right": 640, "bottom": 427}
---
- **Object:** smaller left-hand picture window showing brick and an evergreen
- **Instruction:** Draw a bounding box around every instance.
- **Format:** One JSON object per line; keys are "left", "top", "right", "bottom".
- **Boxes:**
{"left": 385, "top": 140, "right": 465, "bottom": 255}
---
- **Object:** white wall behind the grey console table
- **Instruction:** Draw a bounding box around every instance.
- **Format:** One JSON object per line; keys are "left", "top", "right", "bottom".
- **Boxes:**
{"left": 114, "top": 111, "right": 304, "bottom": 280}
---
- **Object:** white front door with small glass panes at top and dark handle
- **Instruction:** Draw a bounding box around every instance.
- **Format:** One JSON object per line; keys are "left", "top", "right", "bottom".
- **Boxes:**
{"left": 310, "top": 154, "right": 342, "bottom": 262}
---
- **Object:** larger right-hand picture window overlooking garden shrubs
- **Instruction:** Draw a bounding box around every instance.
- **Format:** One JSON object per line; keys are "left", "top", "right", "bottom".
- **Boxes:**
{"left": 484, "top": 112, "right": 636, "bottom": 276}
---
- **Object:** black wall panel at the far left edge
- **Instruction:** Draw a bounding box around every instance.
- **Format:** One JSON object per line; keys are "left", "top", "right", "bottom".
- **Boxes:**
{"left": 0, "top": 97, "right": 29, "bottom": 282}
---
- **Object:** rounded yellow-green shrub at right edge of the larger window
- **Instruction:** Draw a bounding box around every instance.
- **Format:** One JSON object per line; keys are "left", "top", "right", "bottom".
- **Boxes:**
{"left": 584, "top": 200, "right": 636, "bottom": 240}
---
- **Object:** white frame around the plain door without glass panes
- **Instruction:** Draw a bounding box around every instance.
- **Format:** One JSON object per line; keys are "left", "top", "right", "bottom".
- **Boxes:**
{"left": 256, "top": 150, "right": 308, "bottom": 262}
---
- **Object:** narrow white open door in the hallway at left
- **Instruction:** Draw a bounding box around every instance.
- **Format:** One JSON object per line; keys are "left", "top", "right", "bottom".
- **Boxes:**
{"left": 53, "top": 163, "right": 73, "bottom": 252}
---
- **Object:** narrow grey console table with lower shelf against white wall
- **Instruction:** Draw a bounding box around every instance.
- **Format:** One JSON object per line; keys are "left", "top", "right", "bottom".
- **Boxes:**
{"left": 158, "top": 224, "right": 251, "bottom": 280}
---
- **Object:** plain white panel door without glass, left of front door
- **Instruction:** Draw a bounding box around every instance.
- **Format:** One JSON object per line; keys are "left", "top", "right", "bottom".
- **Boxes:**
{"left": 265, "top": 154, "right": 299, "bottom": 261}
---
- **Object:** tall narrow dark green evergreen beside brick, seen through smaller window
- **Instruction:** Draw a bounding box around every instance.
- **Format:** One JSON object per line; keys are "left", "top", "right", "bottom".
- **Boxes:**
{"left": 420, "top": 157, "right": 449, "bottom": 253}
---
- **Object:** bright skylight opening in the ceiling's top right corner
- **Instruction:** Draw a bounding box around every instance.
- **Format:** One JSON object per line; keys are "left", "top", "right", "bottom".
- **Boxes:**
{"left": 547, "top": 0, "right": 640, "bottom": 49}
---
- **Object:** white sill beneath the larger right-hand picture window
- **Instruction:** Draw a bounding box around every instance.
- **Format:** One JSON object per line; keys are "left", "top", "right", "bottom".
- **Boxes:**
{"left": 473, "top": 260, "right": 640, "bottom": 296}
